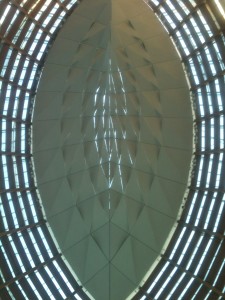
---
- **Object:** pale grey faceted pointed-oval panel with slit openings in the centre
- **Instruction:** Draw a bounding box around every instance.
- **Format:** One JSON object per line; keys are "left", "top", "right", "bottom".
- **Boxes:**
{"left": 33, "top": 0, "right": 192, "bottom": 300}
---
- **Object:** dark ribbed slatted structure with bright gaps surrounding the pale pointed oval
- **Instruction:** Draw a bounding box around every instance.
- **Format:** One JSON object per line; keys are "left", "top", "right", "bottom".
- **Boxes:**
{"left": 0, "top": 0, "right": 225, "bottom": 300}
